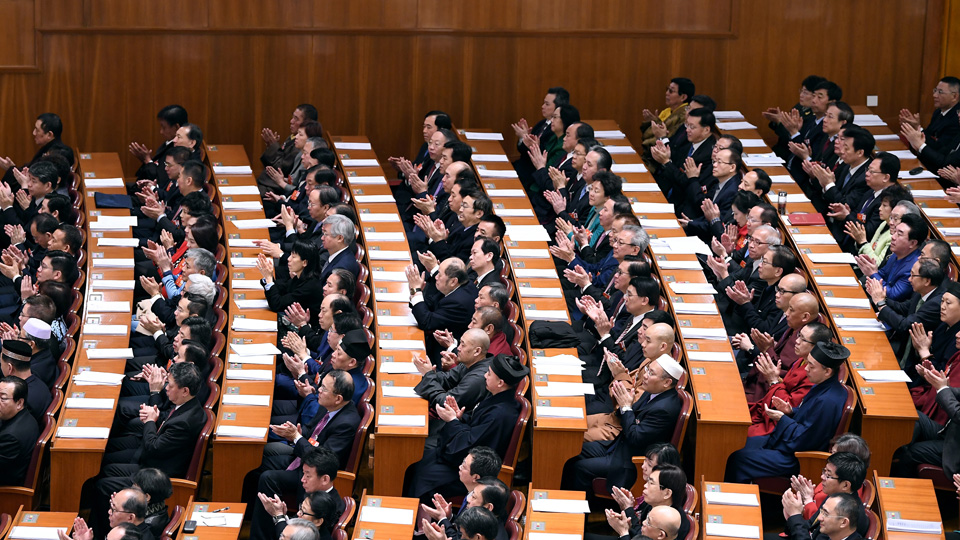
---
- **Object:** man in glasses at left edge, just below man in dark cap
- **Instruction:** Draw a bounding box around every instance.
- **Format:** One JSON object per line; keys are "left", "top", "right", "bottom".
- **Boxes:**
{"left": 0, "top": 376, "right": 40, "bottom": 486}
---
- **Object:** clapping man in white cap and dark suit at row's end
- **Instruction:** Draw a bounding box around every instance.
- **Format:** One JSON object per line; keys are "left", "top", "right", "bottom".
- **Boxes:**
{"left": 561, "top": 355, "right": 683, "bottom": 491}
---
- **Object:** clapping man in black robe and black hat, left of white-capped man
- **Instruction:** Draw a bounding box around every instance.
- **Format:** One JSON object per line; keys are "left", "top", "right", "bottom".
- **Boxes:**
{"left": 404, "top": 355, "right": 530, "bottom": 498}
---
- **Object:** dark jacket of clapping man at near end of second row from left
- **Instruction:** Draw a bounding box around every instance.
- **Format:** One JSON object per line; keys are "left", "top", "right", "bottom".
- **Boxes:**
{"left": 140, "top": 398, "right": 206, "bottom": 478}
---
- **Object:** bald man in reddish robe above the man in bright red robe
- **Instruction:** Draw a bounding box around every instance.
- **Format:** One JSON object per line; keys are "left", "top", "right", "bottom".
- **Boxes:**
{"left": 734, "top": 293, "right": 820, "bottom": 403}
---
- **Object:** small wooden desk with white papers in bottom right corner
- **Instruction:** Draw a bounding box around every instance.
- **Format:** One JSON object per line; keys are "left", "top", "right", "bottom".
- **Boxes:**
{"left": 871, "top": 474, "right": 944, "bottom": 540}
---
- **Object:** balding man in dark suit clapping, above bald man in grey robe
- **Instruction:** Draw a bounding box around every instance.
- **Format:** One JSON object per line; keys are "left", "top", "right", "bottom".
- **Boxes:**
{"left": 406, "top": 257, "right": 477, "bottom": 366}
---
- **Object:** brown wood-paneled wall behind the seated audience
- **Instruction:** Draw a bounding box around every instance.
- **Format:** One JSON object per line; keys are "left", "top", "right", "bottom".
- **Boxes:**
{"left": 0, "top": 0, "right": 944, "bottom": 174}
